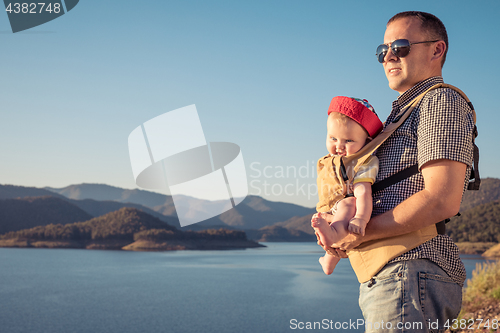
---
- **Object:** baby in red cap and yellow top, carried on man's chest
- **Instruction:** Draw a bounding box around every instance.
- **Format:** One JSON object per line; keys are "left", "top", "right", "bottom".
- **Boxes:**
{"left": 311, "top": 96, "right": 383, "bottom": 275}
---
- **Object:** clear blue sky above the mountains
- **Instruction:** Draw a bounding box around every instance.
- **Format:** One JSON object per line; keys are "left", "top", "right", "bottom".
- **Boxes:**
{"left": 0, "top": 0, "right": 500, "bottom": 207}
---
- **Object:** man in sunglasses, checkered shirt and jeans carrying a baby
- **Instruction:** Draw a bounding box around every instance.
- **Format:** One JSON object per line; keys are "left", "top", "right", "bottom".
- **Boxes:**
{"left": 320, "top": 12, "right": 474, "bottom": 332}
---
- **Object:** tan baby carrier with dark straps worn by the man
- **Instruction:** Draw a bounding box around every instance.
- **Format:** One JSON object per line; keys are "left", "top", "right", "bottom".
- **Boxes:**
{"left": 318, "top": 83, "right": 481, "bottom": 282}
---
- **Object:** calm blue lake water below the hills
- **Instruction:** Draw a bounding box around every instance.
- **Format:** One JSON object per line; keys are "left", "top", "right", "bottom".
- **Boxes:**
{"left": 0, "top": 243, "right": 492, "bottom": 333}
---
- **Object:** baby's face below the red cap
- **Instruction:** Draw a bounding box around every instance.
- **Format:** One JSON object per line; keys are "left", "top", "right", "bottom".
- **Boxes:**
{"left": 326, "top": 117, "right": 368, "bottom": 156}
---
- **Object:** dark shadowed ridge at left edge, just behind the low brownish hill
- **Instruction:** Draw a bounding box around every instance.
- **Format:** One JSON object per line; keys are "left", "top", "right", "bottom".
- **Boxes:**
{"left": 0, "top": 196, "right": 93, "bottom": 234}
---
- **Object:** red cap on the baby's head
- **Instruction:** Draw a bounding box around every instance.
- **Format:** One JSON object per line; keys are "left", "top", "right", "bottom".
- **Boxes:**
{"left": 328, "top": 96, "right": 383, "bottom": 138}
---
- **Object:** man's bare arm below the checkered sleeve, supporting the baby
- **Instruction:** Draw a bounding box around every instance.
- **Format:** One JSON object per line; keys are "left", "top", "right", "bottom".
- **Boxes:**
{"left": 334, "top": 159, "right": 467, "bottom": 250}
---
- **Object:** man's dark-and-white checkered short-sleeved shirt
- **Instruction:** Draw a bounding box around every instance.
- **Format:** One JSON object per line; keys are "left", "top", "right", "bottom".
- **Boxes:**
{"left": 373, "top": 76, "right": 474, "bottom": 286}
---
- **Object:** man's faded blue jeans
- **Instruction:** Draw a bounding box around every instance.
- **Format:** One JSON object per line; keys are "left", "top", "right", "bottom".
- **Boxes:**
{"left": 359, "top": 259, "right": 462, "bottom": 333}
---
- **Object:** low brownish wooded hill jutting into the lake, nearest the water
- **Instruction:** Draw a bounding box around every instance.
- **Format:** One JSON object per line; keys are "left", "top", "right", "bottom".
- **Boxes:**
{"left": 0, "top": 208, "right": 260, "bottom": 250}
